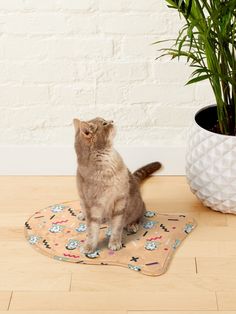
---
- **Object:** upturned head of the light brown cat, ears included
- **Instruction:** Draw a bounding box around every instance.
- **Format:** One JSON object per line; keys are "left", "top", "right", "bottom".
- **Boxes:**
{"left": 73, "top": 118, "right": 115, "bottom": 149}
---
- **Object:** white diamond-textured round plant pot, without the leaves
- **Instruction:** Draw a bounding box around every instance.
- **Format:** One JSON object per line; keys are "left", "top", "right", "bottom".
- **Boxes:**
{"left": 186, "top": 106, "right": 236, "bottom": 214}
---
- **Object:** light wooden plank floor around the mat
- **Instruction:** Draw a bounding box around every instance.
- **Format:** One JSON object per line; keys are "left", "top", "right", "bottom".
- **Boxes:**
{"left": 0, "top": 177, "right": 236, "bottom": 314}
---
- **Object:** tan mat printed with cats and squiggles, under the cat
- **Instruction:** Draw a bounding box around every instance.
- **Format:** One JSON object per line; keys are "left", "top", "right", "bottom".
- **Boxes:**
{"left": 25, "top": 201, "right": 196, "bottom": 276}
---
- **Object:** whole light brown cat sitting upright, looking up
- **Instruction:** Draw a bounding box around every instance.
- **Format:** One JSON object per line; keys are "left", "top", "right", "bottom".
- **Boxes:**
{"left": 73, "top": 118, "right": 161, "bottom": 254}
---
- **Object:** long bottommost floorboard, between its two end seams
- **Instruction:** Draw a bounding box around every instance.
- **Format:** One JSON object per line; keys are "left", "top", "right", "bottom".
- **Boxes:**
{"left": 10, "top": 290, "right": 217, "bottom": 311}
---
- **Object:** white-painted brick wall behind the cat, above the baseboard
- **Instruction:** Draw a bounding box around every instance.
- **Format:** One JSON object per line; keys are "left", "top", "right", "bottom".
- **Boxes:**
{"left": 0, "top": 0, "right": 214, "bottom": 146}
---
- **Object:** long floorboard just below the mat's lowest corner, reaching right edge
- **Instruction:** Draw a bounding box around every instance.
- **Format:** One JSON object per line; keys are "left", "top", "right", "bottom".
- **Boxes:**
{"left": 71, "top": 268, "right": 236, "bottom": 295}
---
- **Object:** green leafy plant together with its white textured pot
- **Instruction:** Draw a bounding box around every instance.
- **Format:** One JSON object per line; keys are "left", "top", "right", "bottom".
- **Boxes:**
{"left": 156, "top": 0, "right": 236, "bottom": 213}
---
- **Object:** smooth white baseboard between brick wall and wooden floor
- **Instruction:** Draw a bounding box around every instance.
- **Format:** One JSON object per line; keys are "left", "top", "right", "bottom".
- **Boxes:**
{"left": 0, "top": 146, "right": 185, "bottom": 175}
